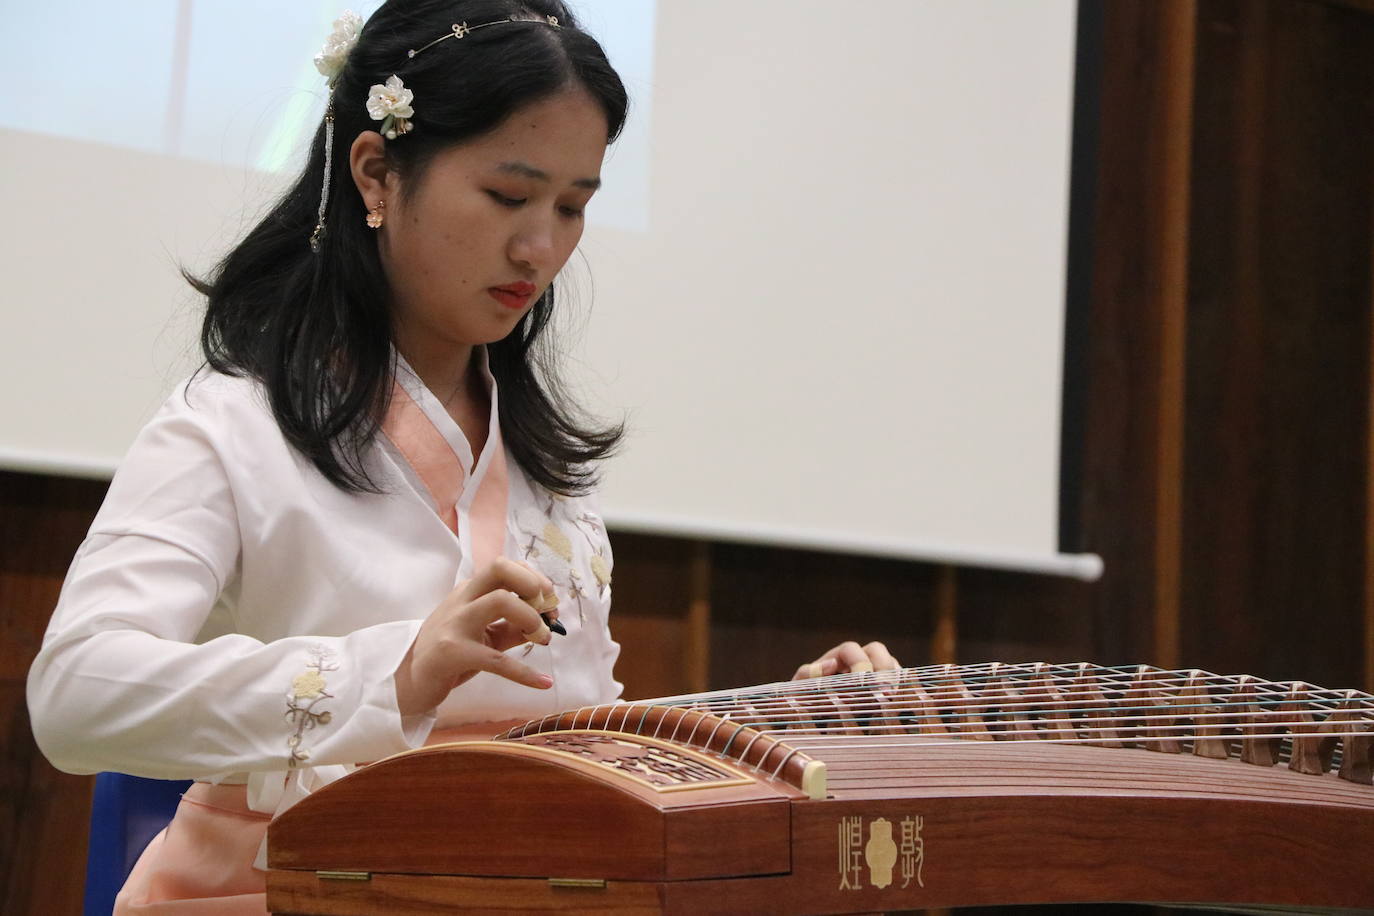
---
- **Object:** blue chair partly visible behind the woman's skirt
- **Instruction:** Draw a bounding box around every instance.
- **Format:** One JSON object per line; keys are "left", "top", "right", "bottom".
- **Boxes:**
{"left": 84, "top": 773, "right": 191, "bottom": 916}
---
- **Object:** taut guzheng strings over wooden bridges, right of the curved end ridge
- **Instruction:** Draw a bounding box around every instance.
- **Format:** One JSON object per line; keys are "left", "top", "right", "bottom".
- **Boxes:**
{"left": 588, "top": 663, "right": 1374, "bottom": 762}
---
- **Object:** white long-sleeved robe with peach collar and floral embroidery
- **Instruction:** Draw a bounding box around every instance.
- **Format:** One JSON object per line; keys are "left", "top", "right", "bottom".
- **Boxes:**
{"left": 29, "top": 350, "right": 620, "bottom": 913}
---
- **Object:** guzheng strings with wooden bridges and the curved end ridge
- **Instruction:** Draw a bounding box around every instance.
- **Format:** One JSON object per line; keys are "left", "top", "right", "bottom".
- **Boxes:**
{"left": 507, "top": 662, "right": 1374, "bottom": 798}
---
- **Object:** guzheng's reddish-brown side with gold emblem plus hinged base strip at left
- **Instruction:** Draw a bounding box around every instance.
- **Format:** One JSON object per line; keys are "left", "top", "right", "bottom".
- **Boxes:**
{"left": 268, "top": 797, "right": 1374, "bottom": 916}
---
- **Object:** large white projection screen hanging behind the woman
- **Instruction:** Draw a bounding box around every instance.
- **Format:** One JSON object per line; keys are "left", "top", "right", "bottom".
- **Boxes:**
{"left": 0, "top": 0, "right": 1101, "bottom": 577}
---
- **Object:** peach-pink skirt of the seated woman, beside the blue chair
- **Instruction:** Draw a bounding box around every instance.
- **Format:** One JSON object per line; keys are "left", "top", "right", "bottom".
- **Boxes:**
{"left": 114, "top": 720, "right": 523, "bottom": 916}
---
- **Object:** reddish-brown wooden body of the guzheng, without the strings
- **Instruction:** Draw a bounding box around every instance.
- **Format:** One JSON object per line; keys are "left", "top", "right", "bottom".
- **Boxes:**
{"left": 268, "top": 713, "right": 1374, "bottom": 913}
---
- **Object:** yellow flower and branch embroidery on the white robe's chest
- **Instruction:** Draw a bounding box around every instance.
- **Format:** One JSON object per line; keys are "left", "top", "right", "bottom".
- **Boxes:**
{"left": 515, "top": 493, "right": 611, "bottom": 623}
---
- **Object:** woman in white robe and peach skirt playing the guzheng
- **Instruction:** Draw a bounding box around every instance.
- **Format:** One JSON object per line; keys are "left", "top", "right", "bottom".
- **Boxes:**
{"left": 29, "top": 0, "right": 896, "bottom": 913}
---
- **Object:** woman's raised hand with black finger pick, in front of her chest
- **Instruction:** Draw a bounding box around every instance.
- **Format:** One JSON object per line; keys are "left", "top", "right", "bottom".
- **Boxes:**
{"left": 396, "top": 556, "right": 558, "bottom": 715}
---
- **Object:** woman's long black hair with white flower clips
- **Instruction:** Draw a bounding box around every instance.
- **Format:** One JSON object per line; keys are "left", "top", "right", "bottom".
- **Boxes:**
{"left": 185, "top": 0, "right": 628, "bottom": 496}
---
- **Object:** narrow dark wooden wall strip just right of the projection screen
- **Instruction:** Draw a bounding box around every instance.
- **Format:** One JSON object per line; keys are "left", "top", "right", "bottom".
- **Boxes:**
{"left": 1081, "top": 0, "right": 1193, "bottom": 662}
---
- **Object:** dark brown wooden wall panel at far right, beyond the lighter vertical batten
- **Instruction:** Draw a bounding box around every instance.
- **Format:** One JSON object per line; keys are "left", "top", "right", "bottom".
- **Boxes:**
{"left": 1184, "top": 0, "right": 1374, "bottom": 687}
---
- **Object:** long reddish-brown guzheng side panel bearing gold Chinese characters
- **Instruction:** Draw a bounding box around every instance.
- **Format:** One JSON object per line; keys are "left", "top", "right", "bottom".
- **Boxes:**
{"left": 769, "top": 797, "right": 1374, "bottom": 913}
